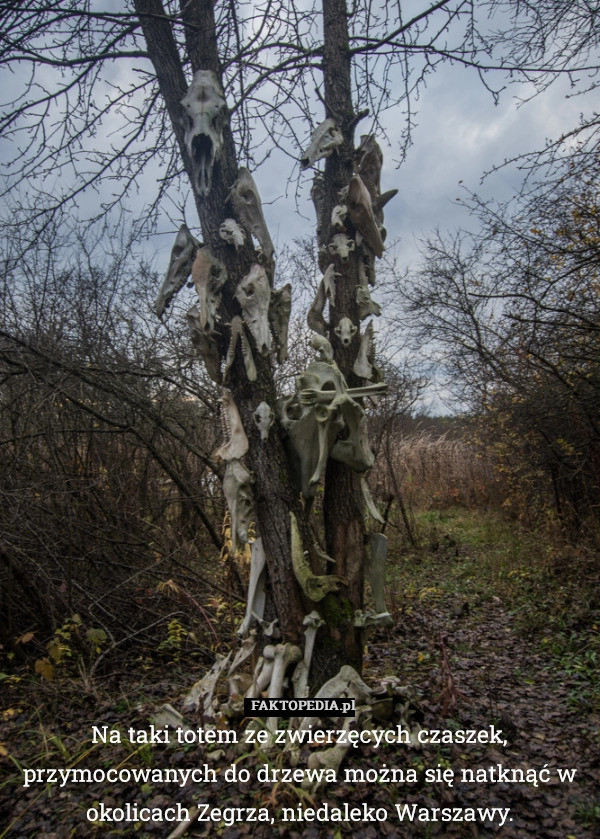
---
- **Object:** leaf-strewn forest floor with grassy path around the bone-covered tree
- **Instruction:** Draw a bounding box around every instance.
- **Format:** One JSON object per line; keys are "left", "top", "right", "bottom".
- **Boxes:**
{"left": 0, "top": 510, "right": 600, "bottom": 839}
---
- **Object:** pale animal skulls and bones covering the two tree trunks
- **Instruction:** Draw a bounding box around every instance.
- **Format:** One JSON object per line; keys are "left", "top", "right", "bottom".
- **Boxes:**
{"left": 155, "top": 70, "right": 396, "bottom": 726}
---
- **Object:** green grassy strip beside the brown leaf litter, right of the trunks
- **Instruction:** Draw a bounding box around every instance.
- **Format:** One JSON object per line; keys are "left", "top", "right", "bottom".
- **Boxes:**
{"left": 388, "top": 508, "right": 600, "bottom": 710}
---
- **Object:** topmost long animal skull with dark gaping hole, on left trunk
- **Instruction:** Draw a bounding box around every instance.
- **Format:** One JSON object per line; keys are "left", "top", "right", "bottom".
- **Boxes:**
{"left": 181, "top": 70, "right": 227, "bottom": 198}
